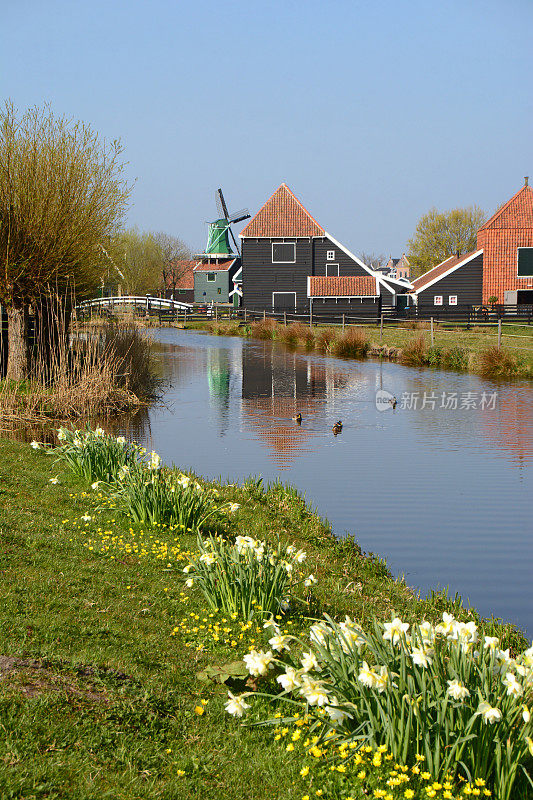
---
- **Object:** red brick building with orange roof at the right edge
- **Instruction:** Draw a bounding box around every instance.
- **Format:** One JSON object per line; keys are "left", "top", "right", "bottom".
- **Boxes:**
{"left": 477, "top": 178, "right": 533, "bottom": 305}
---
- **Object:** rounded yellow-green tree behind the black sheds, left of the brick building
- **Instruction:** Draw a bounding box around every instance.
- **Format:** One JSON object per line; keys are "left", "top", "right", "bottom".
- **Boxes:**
{"left": 408, "top": 206, "right": 485, "bottom": 275}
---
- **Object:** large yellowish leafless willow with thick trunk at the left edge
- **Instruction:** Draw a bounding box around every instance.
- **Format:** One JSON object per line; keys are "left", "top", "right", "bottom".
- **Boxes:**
{"left": 0, "top": 101, "right": 131, "bottom": 380}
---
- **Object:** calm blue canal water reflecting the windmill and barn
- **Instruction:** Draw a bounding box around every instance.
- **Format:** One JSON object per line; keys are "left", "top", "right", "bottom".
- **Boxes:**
{"left": 119, "top": 329, "right": 533, "bottom": 637}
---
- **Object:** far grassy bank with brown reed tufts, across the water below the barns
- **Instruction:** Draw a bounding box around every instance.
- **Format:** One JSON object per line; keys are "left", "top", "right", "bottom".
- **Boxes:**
{"left": 181, "top": 320, "right": 533, "bottom": 378}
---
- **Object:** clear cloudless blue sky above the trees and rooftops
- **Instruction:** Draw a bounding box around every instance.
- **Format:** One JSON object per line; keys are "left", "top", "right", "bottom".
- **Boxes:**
{"left": 0, "top": 0, "right": 533, "bottom": 255}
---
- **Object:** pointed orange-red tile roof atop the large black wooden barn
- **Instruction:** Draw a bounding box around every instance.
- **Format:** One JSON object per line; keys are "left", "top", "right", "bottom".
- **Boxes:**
{"left": 240, "top": 183, "right": 325, "bottom": 238}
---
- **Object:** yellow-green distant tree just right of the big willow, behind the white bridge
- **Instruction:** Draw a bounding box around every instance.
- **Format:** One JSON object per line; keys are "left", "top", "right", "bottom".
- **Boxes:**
{"left": 109, "top": 228, "right": 163, "bottom": 295}
